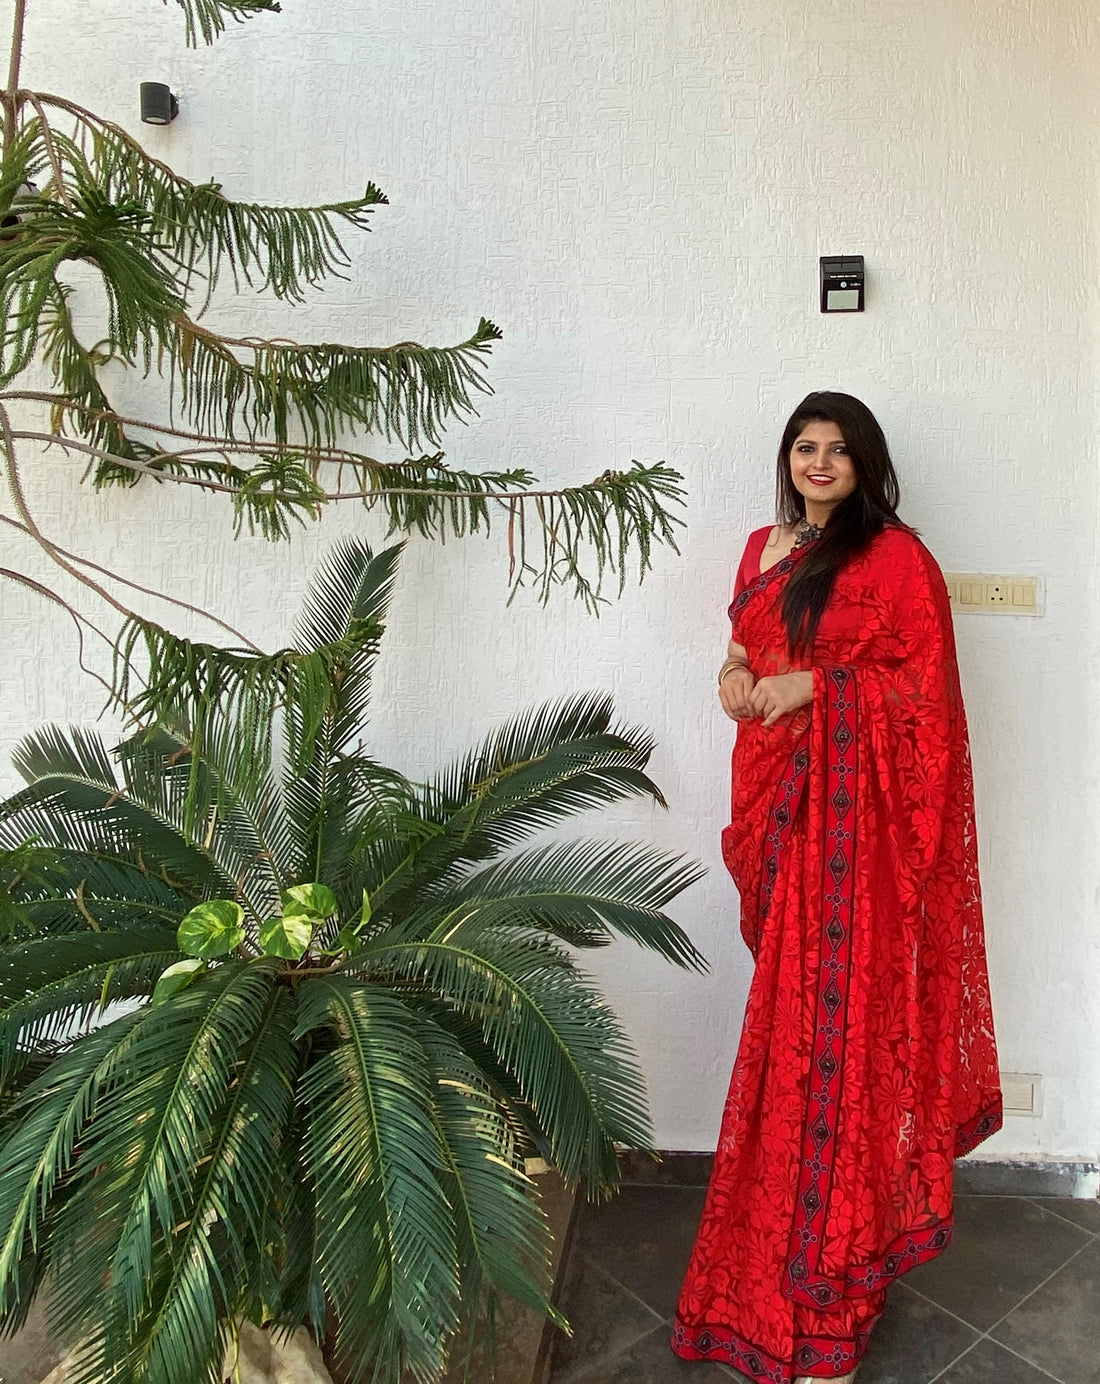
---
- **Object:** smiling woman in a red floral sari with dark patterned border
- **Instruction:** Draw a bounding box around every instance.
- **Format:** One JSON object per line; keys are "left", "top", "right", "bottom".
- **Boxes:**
{"left": 672, "top": 393, "right": 1002, "bottom": 1384}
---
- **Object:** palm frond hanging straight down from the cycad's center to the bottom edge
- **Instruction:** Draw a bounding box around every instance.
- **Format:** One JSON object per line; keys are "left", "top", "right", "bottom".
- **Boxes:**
{"left": 299, "top": 976, "right": 458, "bottom": 1384}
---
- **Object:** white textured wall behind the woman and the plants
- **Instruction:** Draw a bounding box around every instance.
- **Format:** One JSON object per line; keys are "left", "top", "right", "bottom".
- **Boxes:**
{"left": 0, "top": 0, "right": 1100, "bottom": 1161}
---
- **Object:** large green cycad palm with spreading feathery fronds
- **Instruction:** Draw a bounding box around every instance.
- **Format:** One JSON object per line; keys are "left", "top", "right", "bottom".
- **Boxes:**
{"left": 0, "top": 543, "right": 702, "bottom": 1384}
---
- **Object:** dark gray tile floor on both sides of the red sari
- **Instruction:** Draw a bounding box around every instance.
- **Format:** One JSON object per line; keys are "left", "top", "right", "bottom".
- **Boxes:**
{"left": 551, "top": 1185, "right": 1100, "bottom": 1384}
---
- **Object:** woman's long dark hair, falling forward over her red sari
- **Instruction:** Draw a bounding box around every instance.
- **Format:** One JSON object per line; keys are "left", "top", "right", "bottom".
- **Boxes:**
{"left": 775, "top": 390, "right": 901, "bottom": 657}
